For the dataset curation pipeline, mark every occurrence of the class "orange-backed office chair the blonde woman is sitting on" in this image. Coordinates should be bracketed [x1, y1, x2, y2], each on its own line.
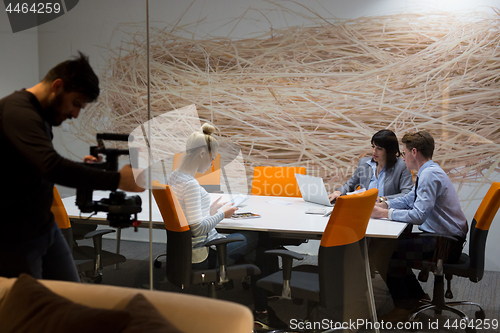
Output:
[153, 181, 260, 298]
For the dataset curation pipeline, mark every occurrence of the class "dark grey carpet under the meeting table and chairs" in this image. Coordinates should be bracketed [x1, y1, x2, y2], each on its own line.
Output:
[82, 240, 500, 332]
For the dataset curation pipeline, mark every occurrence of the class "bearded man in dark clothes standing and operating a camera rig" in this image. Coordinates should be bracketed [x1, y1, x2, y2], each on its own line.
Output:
[0, 52, 144, 281]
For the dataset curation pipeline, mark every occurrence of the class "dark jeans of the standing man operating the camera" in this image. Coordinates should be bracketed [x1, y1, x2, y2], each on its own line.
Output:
[0, 223, 80, 282]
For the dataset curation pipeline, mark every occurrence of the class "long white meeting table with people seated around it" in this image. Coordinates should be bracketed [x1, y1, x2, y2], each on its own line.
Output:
[63, 191, 407, 333]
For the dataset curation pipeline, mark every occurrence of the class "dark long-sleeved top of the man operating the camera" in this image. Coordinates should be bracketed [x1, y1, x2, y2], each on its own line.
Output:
[0, 90, 120, 242]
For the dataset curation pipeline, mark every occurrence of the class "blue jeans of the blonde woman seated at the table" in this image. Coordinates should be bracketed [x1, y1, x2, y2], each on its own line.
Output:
[193, 231, 277, 311]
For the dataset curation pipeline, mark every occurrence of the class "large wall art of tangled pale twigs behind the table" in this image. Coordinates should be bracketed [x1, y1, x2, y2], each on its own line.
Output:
[73, 5, 500, 195]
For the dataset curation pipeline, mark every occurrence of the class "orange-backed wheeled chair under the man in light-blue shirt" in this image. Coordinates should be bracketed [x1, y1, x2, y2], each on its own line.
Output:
[409, 182, 500, 324]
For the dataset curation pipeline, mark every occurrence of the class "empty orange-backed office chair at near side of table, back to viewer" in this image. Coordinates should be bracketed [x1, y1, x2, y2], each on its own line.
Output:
[257, 189, 378, 330]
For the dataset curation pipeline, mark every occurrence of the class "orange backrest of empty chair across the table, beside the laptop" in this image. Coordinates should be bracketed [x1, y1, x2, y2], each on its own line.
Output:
[251, 166, 306, 197]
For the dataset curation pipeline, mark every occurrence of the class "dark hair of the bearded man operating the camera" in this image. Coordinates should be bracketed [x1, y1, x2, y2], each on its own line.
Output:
[43, 51, 99, 102]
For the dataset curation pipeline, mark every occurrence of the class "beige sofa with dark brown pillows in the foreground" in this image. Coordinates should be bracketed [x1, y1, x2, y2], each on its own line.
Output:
[0, 275, 253, 333]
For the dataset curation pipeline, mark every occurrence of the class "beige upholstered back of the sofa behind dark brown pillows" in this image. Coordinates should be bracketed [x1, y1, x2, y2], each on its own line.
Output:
[0, 277, 253, 333]
